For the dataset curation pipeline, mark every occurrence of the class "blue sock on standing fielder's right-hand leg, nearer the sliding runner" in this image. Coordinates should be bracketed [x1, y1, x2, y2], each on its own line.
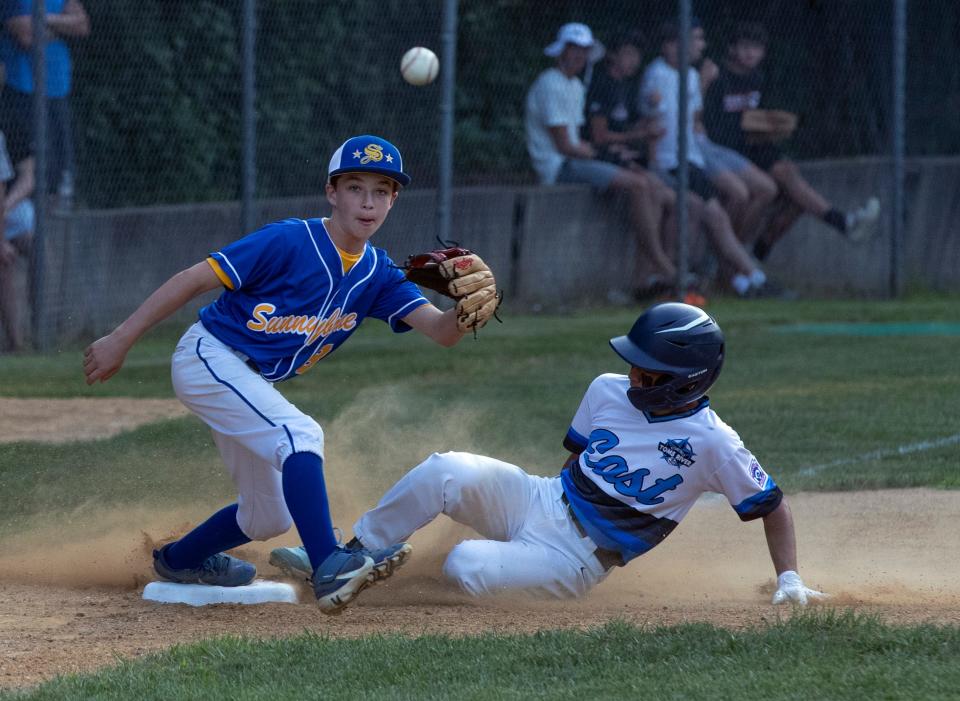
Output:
[283, 453, 337, 569]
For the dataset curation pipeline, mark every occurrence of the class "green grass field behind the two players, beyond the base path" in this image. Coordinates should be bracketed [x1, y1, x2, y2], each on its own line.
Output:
[0, 298, 960, 536]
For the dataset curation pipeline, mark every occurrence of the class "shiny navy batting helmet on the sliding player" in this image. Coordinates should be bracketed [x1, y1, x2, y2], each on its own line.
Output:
[610, 302, 724, 411]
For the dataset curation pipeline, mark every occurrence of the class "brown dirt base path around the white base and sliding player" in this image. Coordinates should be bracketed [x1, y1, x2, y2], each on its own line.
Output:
[0, 489, 960, 687]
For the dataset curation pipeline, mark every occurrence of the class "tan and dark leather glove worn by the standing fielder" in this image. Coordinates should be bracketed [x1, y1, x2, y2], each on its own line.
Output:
[400, 247, 503, 332]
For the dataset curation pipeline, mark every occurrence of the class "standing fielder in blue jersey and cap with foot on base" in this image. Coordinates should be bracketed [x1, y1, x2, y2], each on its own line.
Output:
[83, 136, 495, 613]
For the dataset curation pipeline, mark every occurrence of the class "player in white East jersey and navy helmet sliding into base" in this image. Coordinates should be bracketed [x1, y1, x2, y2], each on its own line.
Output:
[271, 303, 823, 604]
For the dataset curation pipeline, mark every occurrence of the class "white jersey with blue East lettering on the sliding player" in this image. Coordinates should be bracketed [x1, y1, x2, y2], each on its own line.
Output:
[561, 374, 783, 562]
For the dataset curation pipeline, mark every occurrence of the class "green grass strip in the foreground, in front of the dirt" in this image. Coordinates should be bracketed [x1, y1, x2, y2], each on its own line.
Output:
[0, 611, 960, 701]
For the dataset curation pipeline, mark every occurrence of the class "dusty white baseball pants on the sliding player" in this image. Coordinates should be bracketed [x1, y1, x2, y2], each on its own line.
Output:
[353, 453, 607, 598]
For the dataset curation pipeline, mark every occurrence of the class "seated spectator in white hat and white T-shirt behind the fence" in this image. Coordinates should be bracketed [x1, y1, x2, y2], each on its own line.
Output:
[525, 22, 676, 290]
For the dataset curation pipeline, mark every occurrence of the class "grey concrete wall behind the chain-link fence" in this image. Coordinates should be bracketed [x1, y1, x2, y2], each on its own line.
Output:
[9, 158, 960, 342]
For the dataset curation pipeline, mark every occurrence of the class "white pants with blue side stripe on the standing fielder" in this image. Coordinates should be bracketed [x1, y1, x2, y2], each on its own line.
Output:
[171, 321, 323, 540]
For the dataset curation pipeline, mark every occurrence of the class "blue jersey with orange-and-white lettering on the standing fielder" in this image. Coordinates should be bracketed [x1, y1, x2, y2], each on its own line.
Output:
[200, 219, 428, 382]
